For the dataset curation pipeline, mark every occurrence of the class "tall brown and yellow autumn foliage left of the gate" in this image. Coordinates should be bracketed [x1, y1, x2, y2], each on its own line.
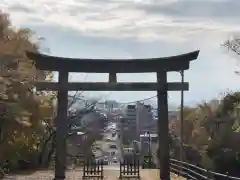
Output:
[0, 13, 52, 173]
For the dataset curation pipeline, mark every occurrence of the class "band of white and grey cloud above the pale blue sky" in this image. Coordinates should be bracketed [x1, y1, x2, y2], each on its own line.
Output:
[0, 0, 240, 42]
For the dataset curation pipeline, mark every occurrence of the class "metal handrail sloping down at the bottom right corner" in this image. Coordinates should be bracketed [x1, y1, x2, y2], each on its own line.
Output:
[170, 159, 240, 180]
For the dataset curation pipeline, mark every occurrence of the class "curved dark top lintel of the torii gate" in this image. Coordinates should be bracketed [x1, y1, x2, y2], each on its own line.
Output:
[26, 51, 199, 73]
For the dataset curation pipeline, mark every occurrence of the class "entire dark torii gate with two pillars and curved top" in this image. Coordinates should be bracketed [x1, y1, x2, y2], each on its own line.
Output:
[26, 51, 199, 180]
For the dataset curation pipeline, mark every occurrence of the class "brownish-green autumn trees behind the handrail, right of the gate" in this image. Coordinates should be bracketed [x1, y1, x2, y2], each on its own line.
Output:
[170, 92, 240, 175]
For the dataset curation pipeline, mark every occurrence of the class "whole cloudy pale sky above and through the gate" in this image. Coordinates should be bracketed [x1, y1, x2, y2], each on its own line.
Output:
[0, 0, 240, 105]
